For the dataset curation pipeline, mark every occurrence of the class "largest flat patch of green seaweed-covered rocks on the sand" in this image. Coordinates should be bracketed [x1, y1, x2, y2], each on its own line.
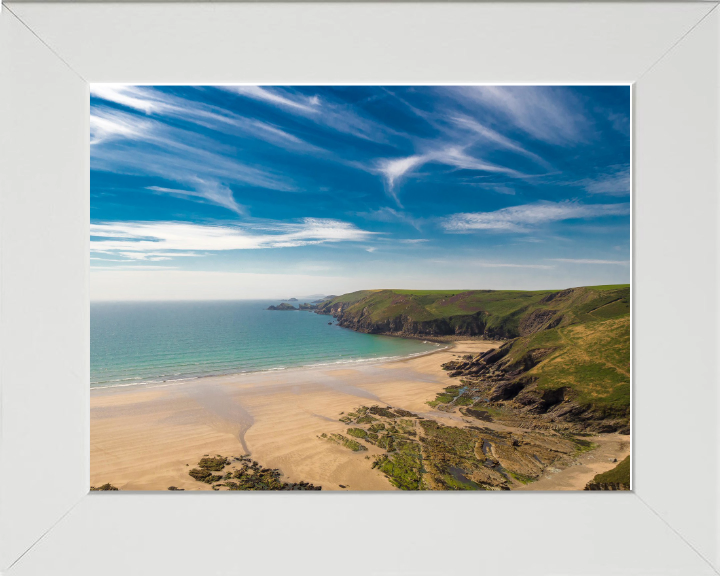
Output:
[318, 405, 595, 490]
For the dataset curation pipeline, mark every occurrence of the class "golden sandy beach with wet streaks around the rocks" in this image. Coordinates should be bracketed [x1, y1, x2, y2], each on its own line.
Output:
[90, 340, 629, 491]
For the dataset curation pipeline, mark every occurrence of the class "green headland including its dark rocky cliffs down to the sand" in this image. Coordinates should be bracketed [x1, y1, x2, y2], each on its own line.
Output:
[316, 286, 630, 434]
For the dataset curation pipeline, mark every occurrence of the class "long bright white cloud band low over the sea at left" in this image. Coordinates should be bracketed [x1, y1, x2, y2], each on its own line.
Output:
[90, 218, 375, 260]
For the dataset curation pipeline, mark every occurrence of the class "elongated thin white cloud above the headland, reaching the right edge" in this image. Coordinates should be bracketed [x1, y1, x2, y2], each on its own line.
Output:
[441, 202, 629, 232]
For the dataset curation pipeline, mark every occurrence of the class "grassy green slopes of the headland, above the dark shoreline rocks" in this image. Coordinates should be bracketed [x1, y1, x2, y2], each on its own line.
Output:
[318, 285, 630, 415]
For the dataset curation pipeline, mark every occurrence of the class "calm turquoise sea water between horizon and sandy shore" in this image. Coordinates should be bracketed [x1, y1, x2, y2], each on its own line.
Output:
[90, 300, 437, 388]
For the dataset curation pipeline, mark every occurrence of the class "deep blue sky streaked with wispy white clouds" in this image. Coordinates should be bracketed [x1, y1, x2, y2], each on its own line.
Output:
[90, 84, 630, 300]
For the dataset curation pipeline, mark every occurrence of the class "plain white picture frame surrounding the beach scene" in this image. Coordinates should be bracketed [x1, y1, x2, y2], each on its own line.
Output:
[0, 1, 720, 576]
